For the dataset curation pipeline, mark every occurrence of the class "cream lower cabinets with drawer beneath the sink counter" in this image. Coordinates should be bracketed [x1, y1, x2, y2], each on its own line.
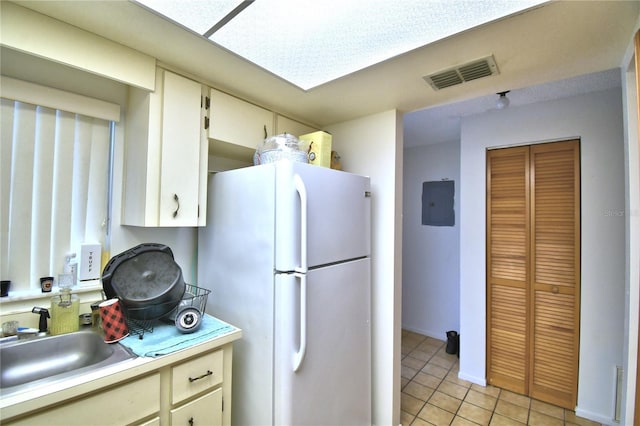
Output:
[2, 343, 232, 426]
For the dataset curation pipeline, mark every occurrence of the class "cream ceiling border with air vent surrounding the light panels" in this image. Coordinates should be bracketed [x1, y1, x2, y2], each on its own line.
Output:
[2, 0, 640, 148]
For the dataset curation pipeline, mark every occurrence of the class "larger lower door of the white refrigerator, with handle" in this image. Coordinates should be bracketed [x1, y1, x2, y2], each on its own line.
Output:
[274, 258, 371, 425]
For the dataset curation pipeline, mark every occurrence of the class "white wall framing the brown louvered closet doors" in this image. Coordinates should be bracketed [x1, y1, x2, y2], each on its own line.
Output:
[460, 89, 625, 424]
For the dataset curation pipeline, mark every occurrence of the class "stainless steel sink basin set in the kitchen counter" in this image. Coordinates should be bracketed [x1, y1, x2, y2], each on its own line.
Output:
[0, 331, 135, 394]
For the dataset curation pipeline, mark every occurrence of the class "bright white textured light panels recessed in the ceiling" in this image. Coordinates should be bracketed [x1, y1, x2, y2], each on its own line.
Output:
[136, 0, 544, 90]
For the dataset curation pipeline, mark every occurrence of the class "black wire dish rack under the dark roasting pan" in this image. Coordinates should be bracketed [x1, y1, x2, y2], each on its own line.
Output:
[125, 284, 211, 339]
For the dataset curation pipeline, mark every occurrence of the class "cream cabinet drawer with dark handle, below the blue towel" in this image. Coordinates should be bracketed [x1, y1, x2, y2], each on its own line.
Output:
[171, 351, 223, 404]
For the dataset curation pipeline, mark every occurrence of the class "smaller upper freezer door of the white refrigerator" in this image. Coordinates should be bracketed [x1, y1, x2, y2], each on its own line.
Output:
[275, 161, 371, 272]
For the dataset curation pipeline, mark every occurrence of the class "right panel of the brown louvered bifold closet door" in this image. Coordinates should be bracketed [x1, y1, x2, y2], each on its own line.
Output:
[530, 141, 580, 409]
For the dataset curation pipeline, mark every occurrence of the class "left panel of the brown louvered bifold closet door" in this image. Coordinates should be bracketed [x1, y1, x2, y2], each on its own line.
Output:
[487, 147, 529, 393]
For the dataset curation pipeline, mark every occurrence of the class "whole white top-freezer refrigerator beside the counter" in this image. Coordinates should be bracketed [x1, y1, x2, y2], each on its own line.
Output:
[198, 160, 371, 426]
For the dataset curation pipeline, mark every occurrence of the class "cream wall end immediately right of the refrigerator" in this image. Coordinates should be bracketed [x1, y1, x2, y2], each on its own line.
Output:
[324, 111, 403, 425]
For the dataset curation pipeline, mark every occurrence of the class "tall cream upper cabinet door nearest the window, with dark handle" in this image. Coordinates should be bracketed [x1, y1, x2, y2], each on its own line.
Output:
[159, 71, 201, 226]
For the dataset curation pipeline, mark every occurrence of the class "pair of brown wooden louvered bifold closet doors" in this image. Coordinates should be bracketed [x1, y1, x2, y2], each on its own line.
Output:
[487, 140, 580, 409]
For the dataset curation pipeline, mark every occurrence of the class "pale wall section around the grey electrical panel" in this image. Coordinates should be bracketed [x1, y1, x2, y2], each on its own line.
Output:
[402, 141, 460, 340]
